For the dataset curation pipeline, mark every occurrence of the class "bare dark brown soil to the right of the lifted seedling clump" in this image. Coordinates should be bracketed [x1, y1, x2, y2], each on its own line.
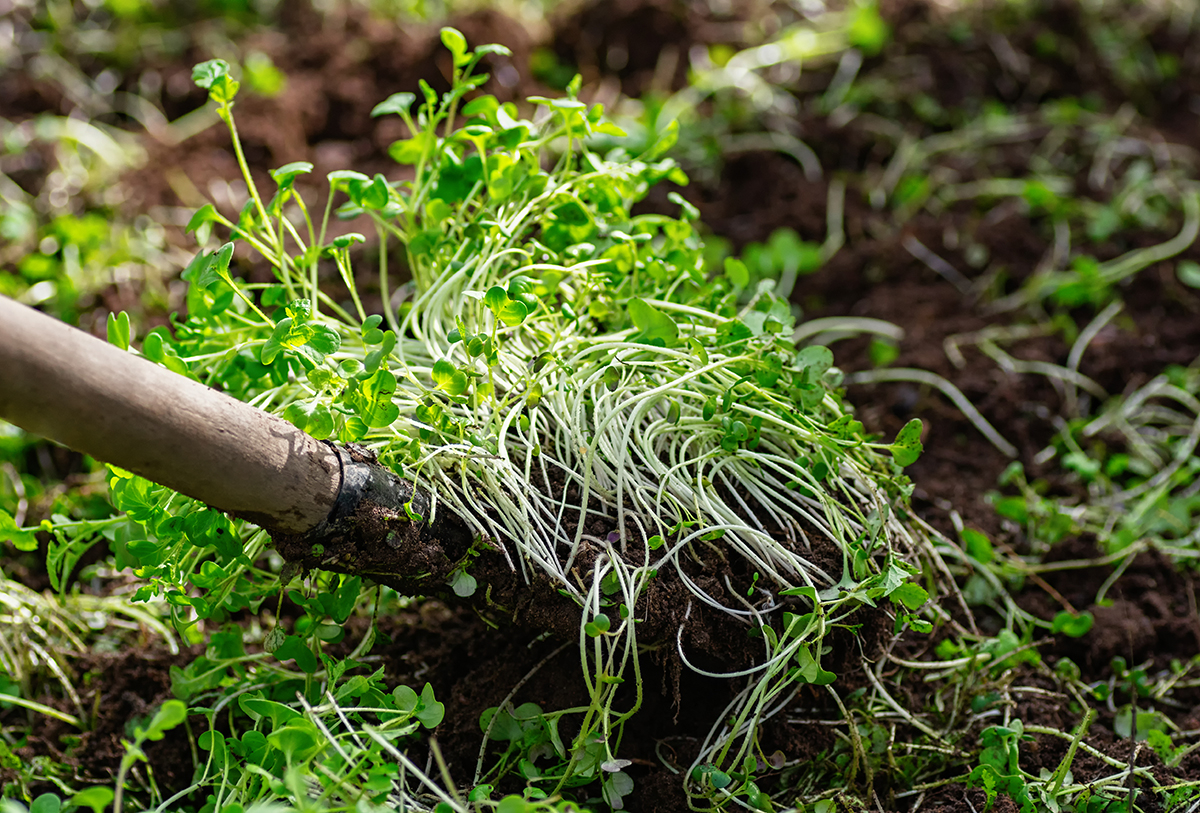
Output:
[660, 2, 1200, 812]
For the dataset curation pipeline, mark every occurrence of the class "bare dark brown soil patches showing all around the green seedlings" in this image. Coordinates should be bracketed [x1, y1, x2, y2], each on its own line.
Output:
[7, 0, 1200, 813]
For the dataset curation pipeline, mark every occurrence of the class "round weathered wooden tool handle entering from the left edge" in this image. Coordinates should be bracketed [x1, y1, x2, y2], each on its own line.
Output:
[0, 296, 342, 534]
